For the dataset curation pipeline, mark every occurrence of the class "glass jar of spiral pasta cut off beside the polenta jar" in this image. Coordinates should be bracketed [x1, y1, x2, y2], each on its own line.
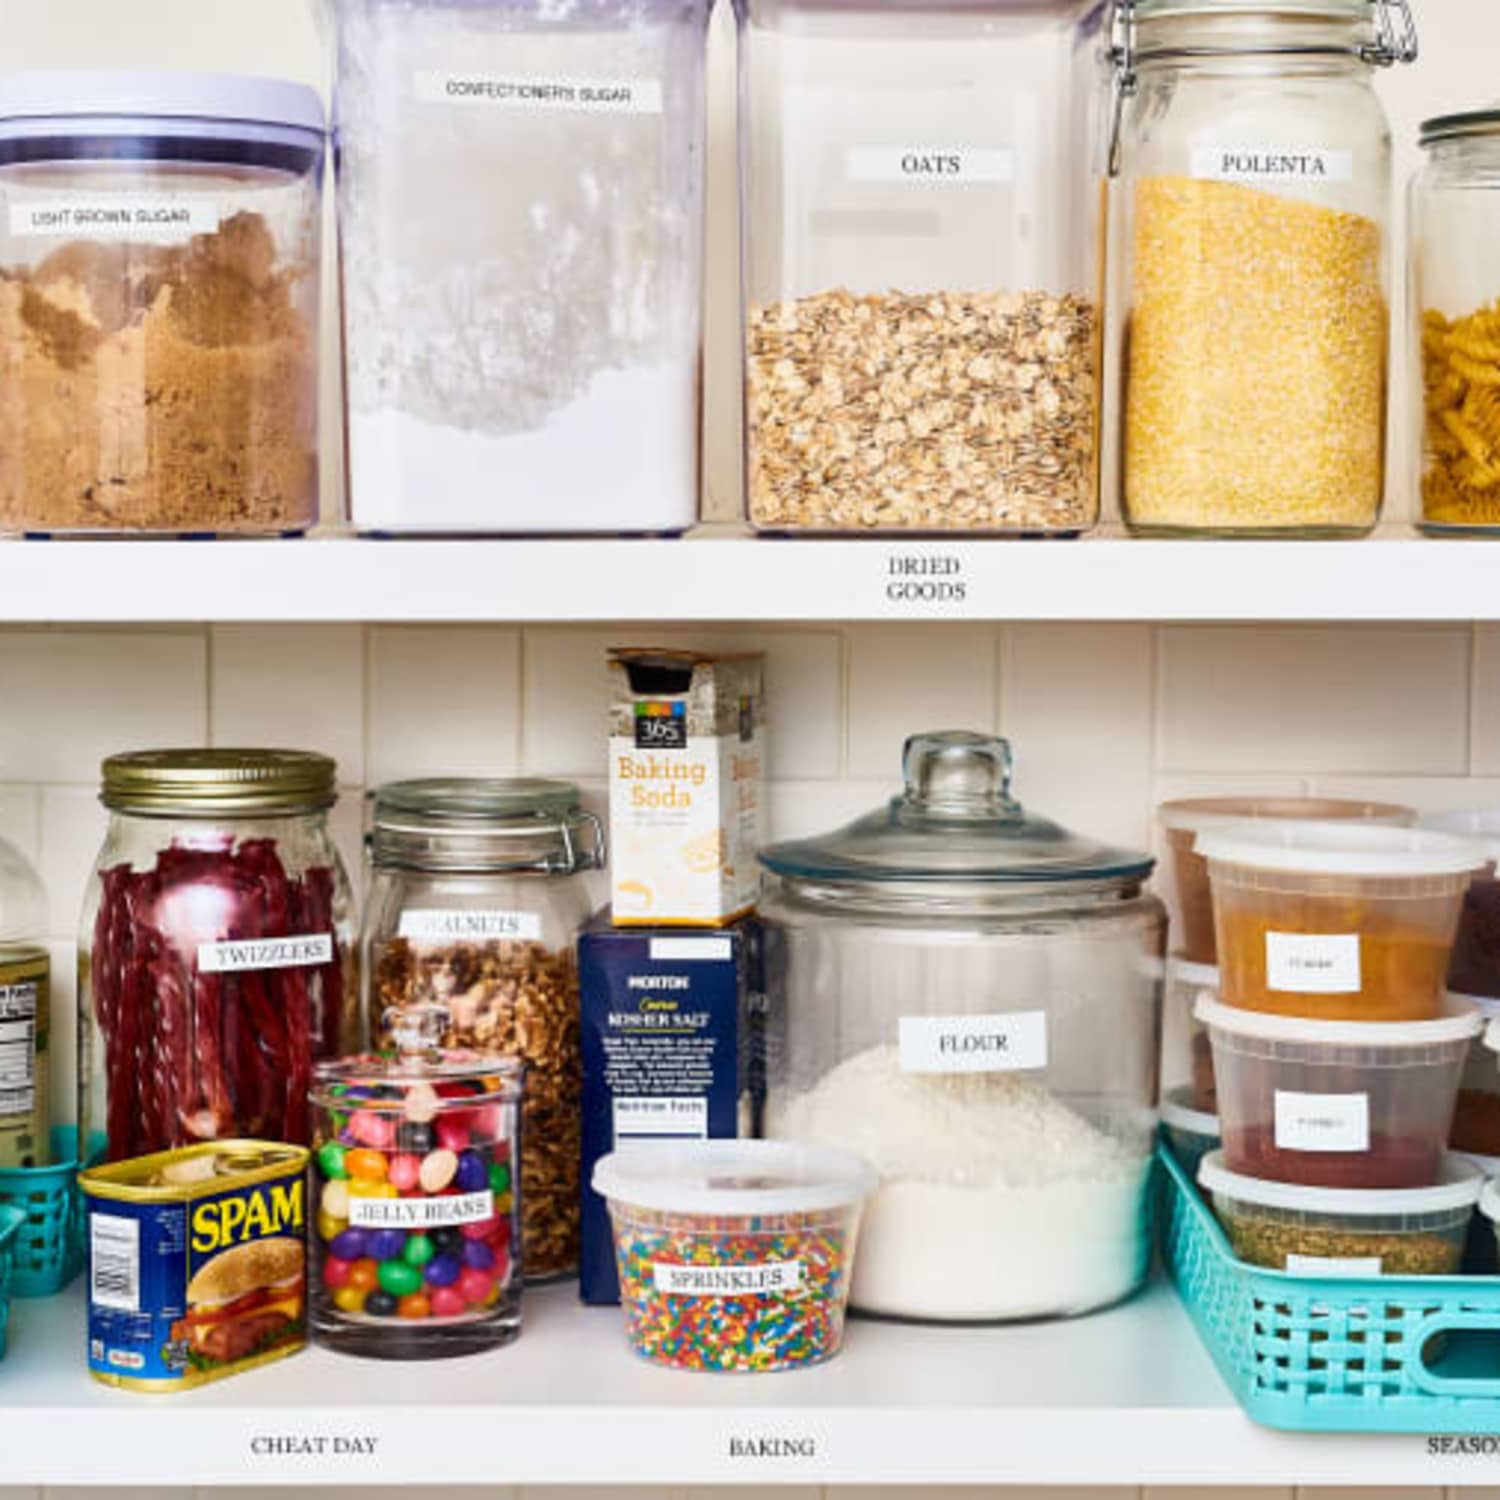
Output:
[1407, 110, 1500, 536]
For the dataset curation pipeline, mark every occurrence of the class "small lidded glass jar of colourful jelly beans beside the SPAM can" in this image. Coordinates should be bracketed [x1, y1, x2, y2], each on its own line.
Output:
[312, 1007, 522, 1359]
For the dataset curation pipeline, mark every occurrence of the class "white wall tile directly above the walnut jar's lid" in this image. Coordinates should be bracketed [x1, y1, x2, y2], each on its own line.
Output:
[366, 626, 521, 786]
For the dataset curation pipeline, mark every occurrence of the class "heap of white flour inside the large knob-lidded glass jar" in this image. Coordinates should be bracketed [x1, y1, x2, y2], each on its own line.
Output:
[767, 1047, 1151, 1320]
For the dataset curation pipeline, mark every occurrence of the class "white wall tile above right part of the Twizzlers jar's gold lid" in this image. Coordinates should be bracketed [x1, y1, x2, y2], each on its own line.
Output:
[209, 626, 365, 785]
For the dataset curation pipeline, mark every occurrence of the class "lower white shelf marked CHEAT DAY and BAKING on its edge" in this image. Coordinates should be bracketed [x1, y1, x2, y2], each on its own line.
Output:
[0, 1284, 1476, 1485]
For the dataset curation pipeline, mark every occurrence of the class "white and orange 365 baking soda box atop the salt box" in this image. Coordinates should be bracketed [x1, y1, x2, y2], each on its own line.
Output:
[609, 650, 765, 927]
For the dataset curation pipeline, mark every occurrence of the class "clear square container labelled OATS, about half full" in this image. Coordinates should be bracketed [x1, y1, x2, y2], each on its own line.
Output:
[737, 0, 1109, 536]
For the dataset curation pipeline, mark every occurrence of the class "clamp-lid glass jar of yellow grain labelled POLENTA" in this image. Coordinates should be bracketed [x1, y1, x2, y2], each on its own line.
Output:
[1119, 0, 1416, 536]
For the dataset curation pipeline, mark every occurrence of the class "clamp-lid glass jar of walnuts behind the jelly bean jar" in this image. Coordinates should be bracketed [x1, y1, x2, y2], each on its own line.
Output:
[363, 779, 605, 1278]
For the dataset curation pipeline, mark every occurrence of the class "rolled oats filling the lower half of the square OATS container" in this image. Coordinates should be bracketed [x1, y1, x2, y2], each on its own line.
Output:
[746, 290, 1100, 533]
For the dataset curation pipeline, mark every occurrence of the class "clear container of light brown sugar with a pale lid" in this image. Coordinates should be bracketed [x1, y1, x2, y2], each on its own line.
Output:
[0, 72, 326, 536]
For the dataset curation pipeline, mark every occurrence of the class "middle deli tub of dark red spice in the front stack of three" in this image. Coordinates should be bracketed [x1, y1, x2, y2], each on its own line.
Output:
[1197, 1001, 1484, 1188]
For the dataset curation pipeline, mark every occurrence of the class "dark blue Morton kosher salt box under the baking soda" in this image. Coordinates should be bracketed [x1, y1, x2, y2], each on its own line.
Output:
[578, 911, 765, 1305]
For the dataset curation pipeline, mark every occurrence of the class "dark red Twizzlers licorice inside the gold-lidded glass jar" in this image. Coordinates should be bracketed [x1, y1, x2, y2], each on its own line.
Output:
[92, 834, 348, 1160]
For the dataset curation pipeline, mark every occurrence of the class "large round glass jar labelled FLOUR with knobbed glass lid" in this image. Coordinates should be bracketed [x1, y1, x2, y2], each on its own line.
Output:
[761, 732, 1166, 1322]
